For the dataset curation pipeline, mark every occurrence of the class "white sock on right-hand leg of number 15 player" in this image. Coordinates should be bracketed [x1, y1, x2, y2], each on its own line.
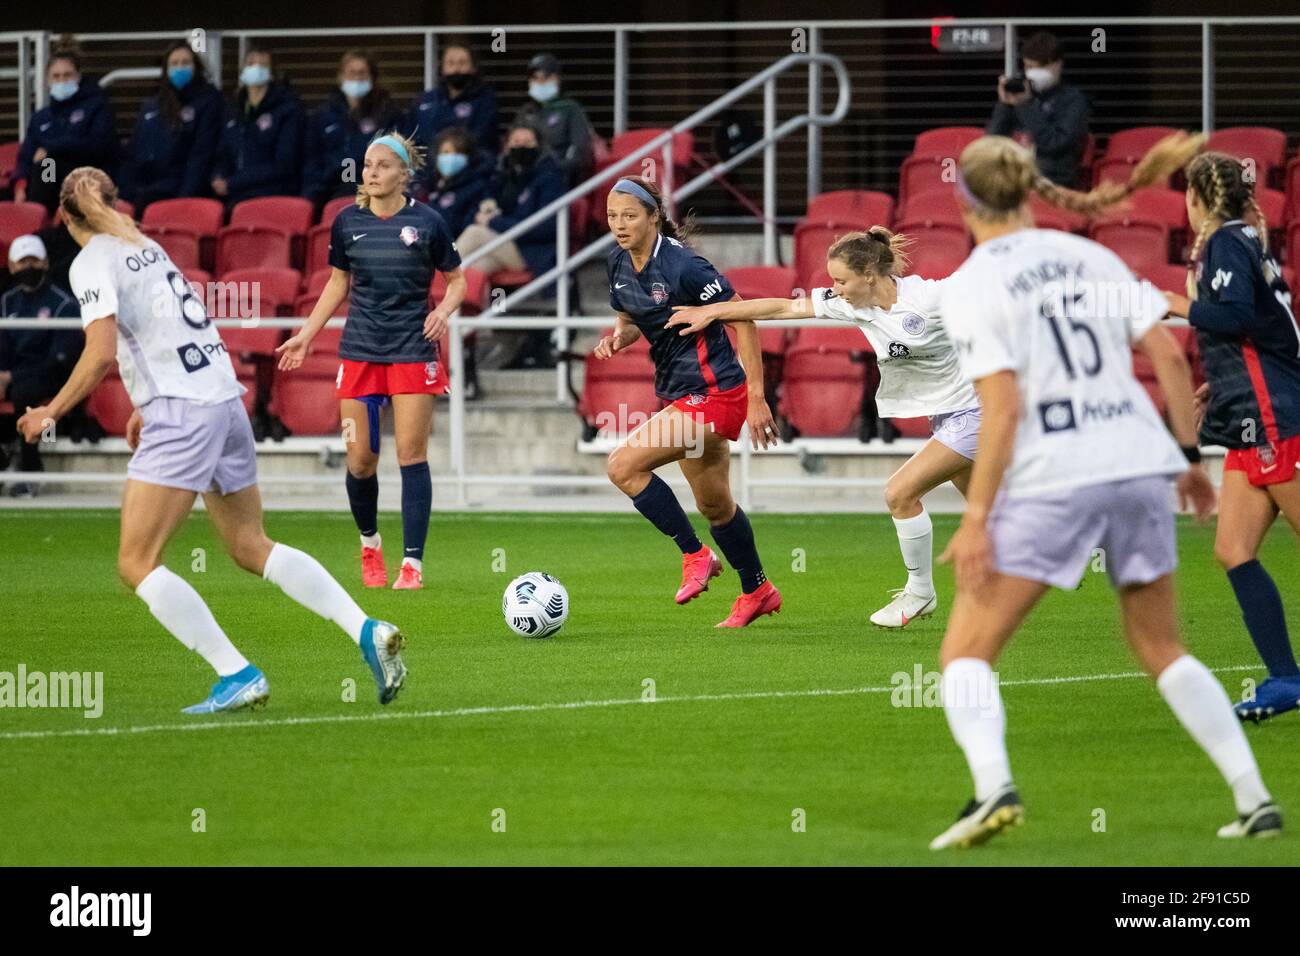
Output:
[1156, 654, 1270, 813]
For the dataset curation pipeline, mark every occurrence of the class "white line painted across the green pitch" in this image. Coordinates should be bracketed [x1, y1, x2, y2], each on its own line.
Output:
[0, 663, 1261, 740]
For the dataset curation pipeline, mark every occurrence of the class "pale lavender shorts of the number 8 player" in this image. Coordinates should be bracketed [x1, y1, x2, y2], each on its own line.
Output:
[126, 398, 257, 494]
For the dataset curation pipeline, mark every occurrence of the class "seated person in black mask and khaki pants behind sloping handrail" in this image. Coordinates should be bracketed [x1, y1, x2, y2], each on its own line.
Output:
[456, 122, 568, 368]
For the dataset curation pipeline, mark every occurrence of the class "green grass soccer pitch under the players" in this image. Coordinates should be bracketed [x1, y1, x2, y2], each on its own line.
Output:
[0, 510, 1300, 865]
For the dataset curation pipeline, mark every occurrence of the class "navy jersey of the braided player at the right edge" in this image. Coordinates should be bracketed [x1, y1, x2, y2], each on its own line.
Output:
[1188, 220, 1300, 449]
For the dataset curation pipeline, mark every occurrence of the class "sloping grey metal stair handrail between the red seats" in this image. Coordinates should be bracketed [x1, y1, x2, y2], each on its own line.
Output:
[463, 53, 849, 401]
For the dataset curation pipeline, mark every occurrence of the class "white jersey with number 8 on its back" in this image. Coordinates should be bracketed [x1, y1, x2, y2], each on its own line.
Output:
[69, 234, 244, 408]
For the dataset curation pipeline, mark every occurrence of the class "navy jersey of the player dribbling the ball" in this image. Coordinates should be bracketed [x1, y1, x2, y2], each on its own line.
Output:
[608, 235, 745, 402]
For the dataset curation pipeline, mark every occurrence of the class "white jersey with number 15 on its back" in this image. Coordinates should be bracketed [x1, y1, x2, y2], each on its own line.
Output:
[943, 229, 1187, 497]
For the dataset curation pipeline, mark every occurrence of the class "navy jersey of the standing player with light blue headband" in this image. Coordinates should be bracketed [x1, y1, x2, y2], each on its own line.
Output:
[329, 199, 460, 363]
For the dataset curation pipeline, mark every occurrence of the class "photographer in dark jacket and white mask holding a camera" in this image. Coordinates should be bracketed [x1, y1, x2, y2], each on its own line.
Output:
[985, 31, 1088, 187]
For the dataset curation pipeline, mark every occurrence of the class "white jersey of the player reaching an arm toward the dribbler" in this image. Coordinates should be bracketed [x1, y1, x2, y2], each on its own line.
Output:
[813, 276, 979, 419]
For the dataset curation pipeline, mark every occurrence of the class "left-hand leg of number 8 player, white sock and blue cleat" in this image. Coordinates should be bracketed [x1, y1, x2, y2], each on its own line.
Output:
[117, 479, 269, 713]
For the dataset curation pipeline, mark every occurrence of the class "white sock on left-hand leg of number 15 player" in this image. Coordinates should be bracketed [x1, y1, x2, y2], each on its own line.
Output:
[941, 657, 1011, 800]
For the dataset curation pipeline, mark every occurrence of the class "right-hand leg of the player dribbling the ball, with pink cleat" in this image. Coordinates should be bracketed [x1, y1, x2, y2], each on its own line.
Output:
[679, 415, 781, 627]
